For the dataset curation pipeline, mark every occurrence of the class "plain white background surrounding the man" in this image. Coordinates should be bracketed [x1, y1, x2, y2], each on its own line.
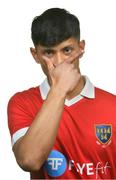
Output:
[0, 0, 116, 180]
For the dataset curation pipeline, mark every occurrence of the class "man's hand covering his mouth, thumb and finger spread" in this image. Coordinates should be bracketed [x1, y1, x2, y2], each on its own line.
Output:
[43, 51, 84, 94]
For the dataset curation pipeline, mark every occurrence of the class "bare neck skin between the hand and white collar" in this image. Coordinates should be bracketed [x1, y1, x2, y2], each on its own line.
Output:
[66, 76, 85, 100]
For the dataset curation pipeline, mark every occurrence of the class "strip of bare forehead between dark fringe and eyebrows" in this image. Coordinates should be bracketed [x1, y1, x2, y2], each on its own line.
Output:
[37, 38, 78, 50]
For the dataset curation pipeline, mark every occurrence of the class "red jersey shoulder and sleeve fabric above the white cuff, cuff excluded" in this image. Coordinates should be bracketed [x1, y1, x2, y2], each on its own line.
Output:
[7, 87, 42, 135]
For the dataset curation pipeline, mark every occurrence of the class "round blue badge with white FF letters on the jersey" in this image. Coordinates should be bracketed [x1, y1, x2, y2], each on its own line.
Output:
[44, 150, 67, 177]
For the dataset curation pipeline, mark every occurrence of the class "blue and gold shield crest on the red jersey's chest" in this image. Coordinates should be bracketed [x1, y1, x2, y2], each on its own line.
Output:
[95, 124, 112, 145]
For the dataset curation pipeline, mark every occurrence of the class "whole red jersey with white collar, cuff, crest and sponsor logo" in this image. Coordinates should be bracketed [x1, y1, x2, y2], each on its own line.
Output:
[8, 77, 116, 179]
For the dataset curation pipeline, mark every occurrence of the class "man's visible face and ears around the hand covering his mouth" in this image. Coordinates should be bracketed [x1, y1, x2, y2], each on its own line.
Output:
[30, 38, 85, 76]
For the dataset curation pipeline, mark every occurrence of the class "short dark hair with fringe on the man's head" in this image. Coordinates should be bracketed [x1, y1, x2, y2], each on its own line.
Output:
[31, 8, 80, 46]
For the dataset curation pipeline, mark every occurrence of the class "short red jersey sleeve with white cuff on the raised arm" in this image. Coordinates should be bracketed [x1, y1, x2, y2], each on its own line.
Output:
[8, 93, 34, 146]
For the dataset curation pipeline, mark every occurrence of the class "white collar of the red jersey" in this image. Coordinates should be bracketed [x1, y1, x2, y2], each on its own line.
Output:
[39, 76, 95, 106]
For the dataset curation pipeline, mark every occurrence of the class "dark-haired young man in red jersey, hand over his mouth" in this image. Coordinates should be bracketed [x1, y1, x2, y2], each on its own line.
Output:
[8, 8, 116, 179]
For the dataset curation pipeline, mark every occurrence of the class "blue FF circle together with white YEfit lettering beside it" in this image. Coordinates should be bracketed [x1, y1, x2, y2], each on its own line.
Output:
[44, 150, 111, 179]
